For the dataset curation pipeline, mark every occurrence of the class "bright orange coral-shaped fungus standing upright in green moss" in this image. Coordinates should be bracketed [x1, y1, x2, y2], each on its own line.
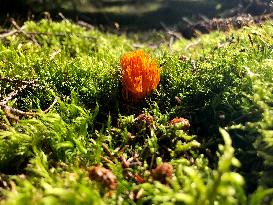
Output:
[120, 50, 160, 102]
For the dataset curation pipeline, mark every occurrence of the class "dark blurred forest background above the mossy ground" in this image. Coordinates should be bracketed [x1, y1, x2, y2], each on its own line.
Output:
[0, 0, 272, 31]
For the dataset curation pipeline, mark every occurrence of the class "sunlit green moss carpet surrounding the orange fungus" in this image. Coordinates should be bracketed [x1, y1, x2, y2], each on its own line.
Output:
[0, 20, 273, 204]
